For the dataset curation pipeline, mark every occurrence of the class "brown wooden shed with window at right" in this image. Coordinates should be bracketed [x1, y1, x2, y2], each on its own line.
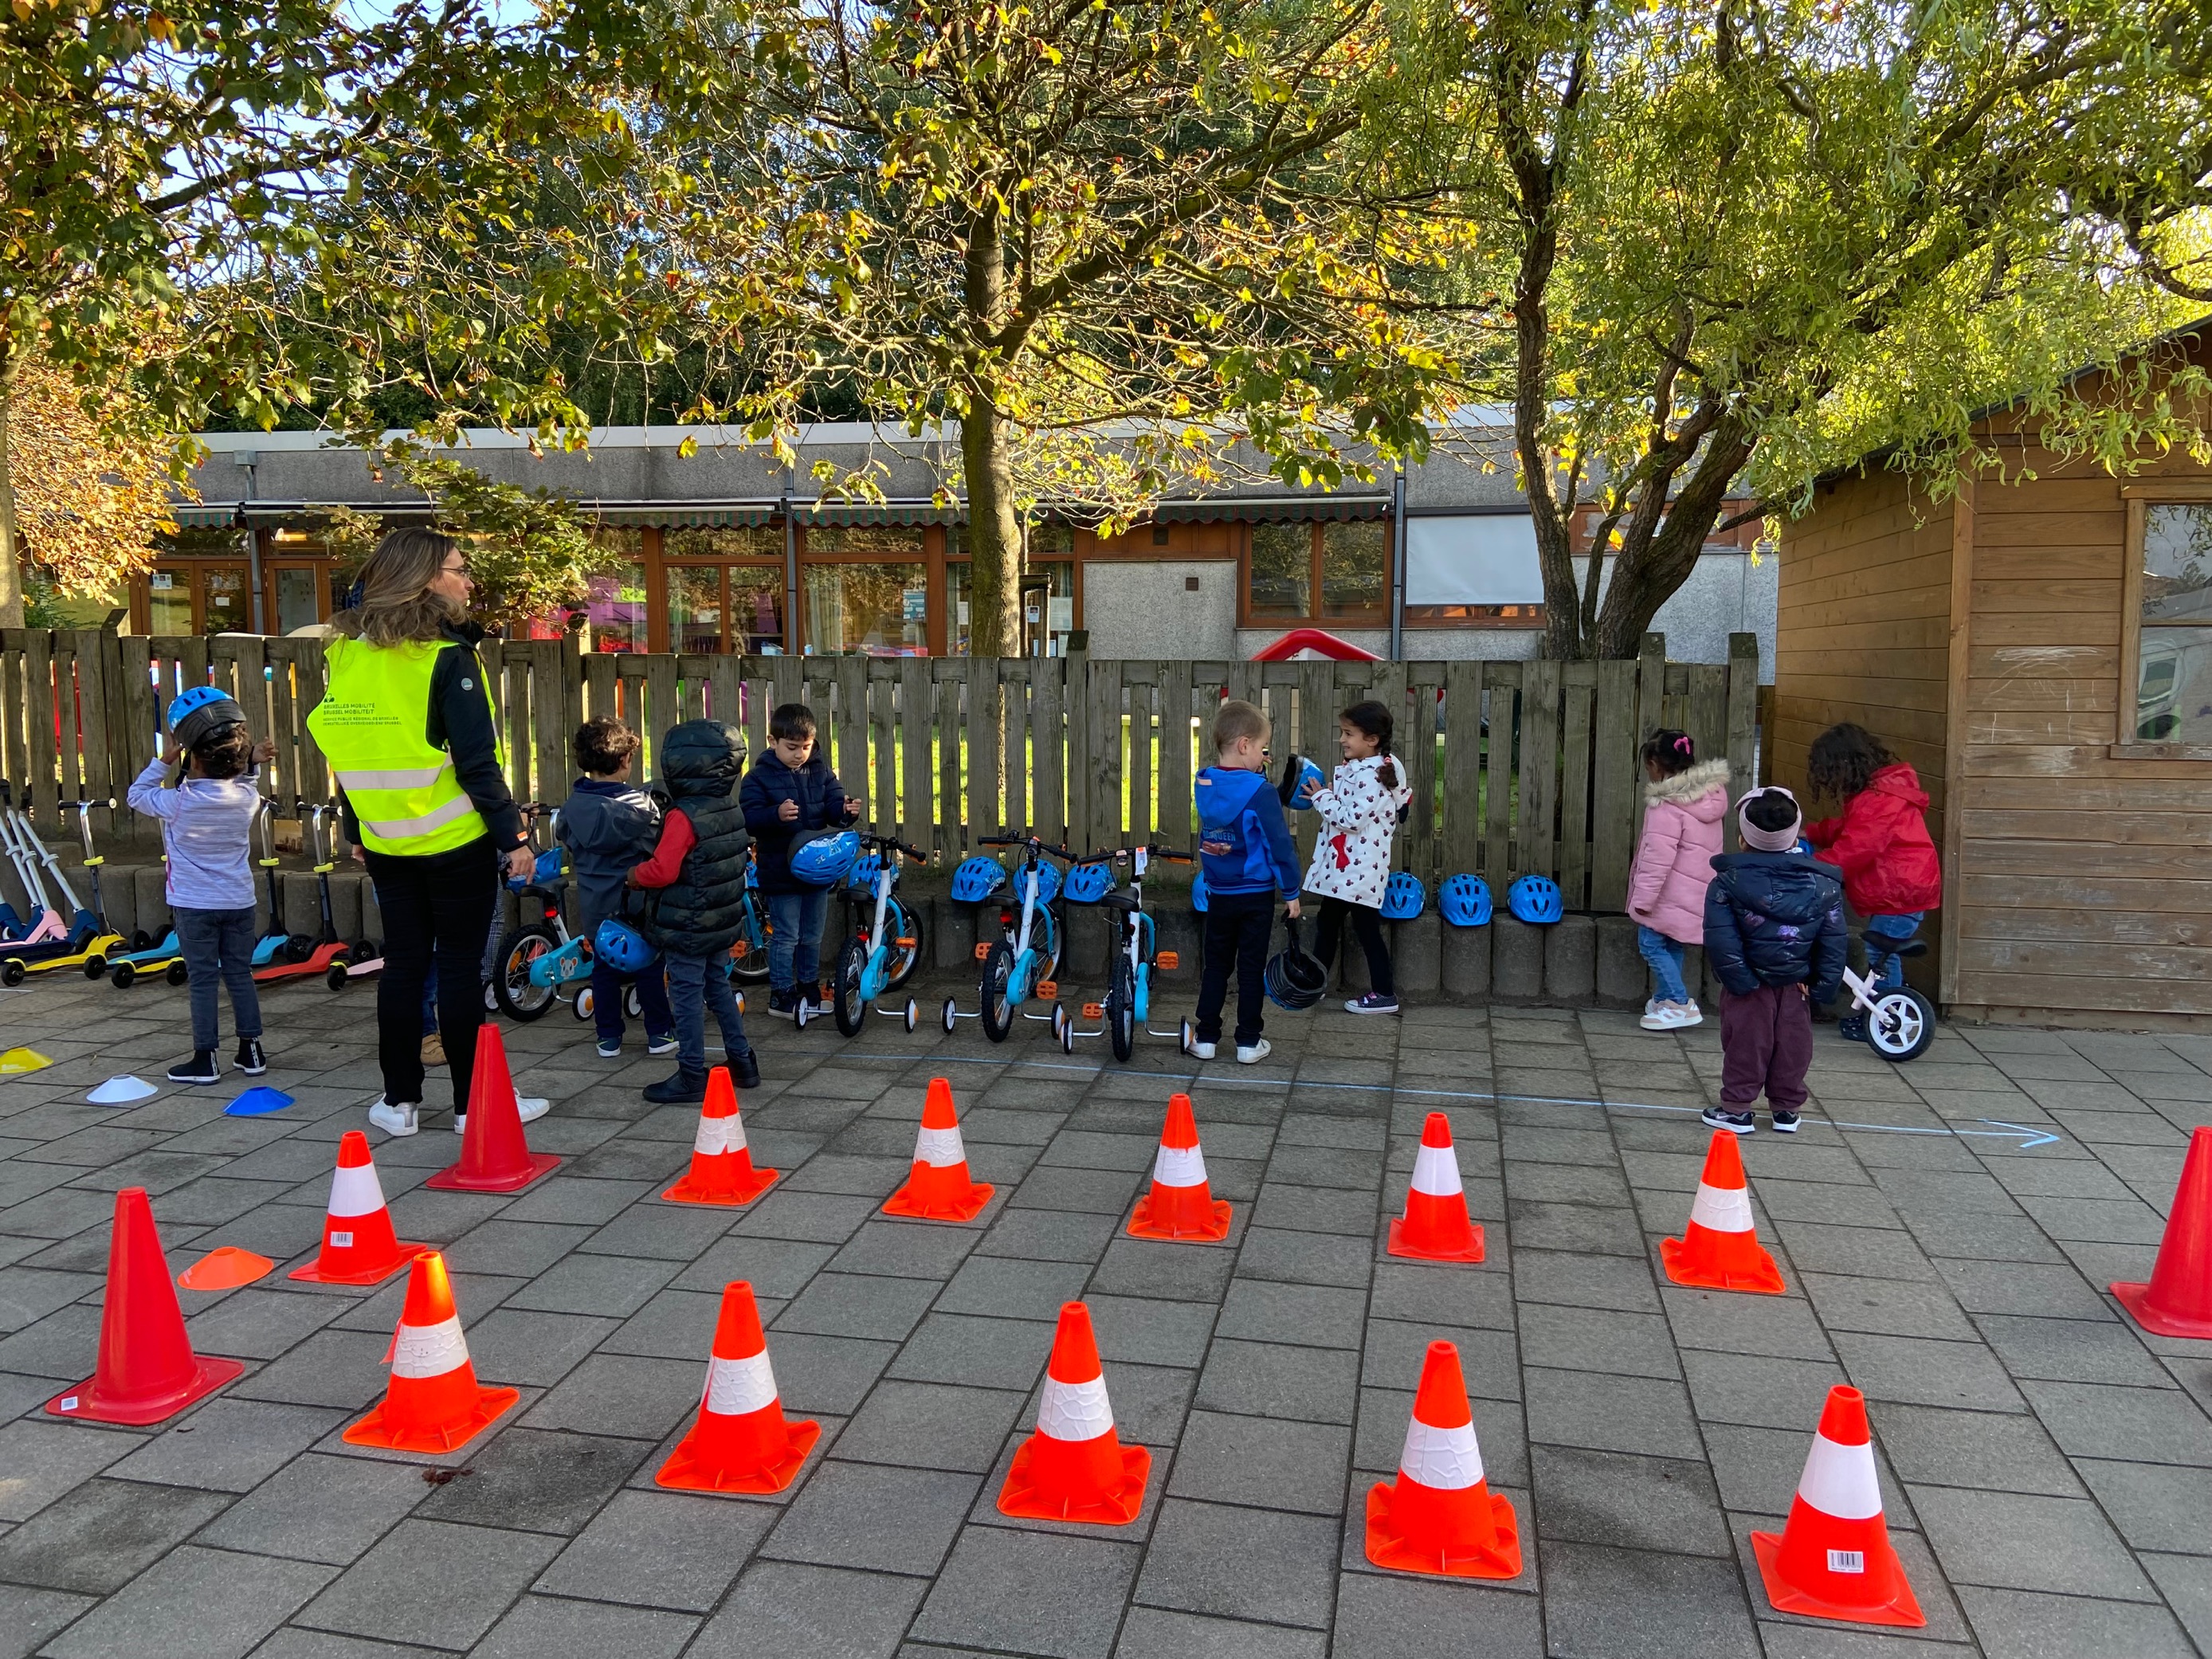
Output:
[1765, 319, 2212, 1029]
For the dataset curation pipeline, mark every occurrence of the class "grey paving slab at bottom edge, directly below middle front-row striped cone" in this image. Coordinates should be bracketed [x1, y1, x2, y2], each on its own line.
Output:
[913, 1526, 1139, 1659]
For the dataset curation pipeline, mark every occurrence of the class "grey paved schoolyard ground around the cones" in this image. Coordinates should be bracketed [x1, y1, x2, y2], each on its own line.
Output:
[0, 980, 2212, 1659]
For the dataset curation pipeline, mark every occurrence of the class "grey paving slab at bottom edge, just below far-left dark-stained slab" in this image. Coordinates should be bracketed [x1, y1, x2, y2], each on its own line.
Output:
[45, 1546, 334, 1659]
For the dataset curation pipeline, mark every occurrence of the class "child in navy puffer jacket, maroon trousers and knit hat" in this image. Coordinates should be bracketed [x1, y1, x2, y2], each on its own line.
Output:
[1705, 787, 1845, 1135]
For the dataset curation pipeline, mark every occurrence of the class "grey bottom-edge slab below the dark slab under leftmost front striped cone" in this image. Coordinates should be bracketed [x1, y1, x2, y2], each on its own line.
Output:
[294, 1530, 559, 1648]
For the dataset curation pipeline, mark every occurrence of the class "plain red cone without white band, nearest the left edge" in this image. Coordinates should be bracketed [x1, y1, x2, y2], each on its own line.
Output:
[46, 1186, 245, 1429]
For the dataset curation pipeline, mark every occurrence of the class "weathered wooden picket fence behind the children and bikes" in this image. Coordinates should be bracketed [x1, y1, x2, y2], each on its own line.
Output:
[0, 628, 1759, 909]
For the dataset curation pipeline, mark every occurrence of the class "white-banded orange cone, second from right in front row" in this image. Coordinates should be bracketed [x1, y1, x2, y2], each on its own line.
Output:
[1367, 1343, 1522, 1579]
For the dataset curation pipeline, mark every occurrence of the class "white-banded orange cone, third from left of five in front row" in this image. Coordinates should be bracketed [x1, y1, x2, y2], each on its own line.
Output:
[998, 1303, 1152, 1526]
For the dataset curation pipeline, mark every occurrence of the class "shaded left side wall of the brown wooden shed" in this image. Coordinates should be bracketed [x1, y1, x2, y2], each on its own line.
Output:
[1765, 473, 1953, 991]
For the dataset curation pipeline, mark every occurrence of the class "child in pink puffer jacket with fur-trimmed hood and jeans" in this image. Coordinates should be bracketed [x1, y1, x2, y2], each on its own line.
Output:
[1628, 730, 1728, 1031]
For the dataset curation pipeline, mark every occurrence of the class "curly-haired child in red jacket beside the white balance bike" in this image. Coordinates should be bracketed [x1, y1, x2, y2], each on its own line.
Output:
[1805, 721, 1942, 1037]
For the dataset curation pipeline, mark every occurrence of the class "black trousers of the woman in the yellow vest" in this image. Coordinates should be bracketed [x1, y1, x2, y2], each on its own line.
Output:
[365, 836, 500, 1115]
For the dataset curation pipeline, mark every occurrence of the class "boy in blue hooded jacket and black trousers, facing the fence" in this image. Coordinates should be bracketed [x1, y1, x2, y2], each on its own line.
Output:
[1190, 701, 1299, 1066]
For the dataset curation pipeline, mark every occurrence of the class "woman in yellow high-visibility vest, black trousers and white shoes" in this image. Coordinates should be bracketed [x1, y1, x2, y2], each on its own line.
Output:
[308, 528, 547, 1135]
